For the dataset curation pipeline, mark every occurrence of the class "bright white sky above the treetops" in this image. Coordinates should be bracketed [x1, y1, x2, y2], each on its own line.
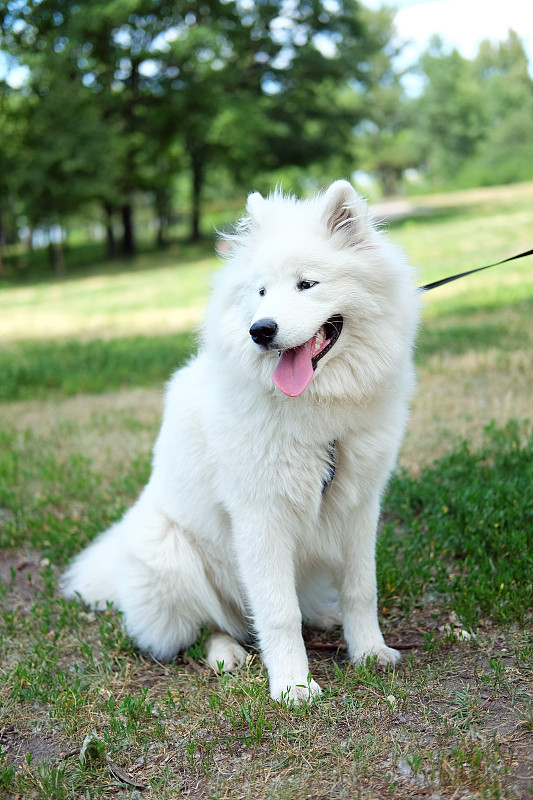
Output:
[0, 0, 533, 85]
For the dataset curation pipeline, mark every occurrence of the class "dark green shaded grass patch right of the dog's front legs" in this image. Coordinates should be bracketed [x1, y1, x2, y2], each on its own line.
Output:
[378, 423, 533, 628]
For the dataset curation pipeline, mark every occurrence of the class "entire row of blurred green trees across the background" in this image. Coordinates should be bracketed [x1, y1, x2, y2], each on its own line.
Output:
[0, 0, 533, 274]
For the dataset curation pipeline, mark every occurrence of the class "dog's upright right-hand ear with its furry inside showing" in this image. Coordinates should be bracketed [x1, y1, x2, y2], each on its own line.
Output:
[322, 181, 367, 244]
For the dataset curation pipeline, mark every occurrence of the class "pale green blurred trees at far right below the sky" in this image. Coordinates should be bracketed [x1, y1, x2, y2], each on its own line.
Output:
[416, 31, 533, 186]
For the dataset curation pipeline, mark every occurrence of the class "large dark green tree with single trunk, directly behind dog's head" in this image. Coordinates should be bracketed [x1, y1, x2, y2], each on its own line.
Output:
[155, 0, 381, 238]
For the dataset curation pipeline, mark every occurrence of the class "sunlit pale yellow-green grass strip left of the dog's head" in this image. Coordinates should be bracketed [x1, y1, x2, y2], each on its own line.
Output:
[0, 255, 219, 343]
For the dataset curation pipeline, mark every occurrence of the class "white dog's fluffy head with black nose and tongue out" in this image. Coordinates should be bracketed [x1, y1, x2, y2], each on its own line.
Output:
[206, 181, 418, 397]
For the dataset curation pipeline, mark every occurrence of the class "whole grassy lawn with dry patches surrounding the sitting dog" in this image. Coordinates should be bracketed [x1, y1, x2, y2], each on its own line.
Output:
[0, 184, 533, 800]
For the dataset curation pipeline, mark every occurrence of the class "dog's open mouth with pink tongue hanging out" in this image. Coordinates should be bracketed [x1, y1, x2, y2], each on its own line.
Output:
[272, 314, 343, 397]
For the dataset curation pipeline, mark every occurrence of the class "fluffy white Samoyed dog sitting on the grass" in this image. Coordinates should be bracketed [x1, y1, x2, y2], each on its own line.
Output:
[63, 180, 419, 703]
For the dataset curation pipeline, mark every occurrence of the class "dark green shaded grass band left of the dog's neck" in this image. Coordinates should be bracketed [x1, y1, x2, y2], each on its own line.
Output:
[0, 332, 196, 402]
